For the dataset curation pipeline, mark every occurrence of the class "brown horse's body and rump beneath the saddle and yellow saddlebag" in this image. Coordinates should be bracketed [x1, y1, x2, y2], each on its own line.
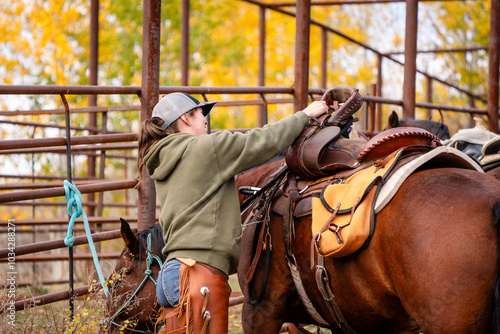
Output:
[237, 155, 500, 334]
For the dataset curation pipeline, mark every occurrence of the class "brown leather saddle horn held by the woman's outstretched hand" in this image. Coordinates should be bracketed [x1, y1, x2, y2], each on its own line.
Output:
[321, 86, 363, 126]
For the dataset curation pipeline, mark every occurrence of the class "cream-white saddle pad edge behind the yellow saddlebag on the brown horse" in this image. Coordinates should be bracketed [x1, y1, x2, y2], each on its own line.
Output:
[374, 146, 484, 213]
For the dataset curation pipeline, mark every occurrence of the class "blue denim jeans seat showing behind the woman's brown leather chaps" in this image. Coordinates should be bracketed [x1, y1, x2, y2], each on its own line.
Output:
[156, 259, 181, 307]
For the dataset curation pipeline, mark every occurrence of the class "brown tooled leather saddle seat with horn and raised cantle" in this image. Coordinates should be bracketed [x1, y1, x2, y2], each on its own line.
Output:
[285, 86, 438, 180]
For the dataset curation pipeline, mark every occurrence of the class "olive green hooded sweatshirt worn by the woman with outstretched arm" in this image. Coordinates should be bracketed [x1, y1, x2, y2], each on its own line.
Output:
[144, 112, 308, 275]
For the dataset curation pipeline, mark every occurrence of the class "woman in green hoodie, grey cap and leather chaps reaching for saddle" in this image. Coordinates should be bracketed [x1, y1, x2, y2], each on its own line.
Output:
[137, 93, 328, 333]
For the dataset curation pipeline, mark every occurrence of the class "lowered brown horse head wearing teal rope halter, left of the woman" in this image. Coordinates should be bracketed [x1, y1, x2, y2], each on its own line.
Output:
[106, 219, 165, 333]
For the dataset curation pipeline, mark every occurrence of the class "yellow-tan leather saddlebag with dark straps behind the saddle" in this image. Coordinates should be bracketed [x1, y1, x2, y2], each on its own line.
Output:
[311, 149, 404, 258]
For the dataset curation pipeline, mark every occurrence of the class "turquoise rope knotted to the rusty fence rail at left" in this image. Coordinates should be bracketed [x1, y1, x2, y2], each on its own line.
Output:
[63, 180, 108, 297]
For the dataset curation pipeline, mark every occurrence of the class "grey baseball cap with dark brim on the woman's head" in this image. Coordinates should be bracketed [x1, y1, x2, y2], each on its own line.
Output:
[151, 93, 217, 130]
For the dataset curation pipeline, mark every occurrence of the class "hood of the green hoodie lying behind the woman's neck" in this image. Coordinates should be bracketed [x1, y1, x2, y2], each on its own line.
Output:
[143, 133, 196, 181]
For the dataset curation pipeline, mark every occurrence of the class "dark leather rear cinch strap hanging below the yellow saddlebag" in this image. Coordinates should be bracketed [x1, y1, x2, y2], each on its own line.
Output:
[316, 254, 356, 334]
